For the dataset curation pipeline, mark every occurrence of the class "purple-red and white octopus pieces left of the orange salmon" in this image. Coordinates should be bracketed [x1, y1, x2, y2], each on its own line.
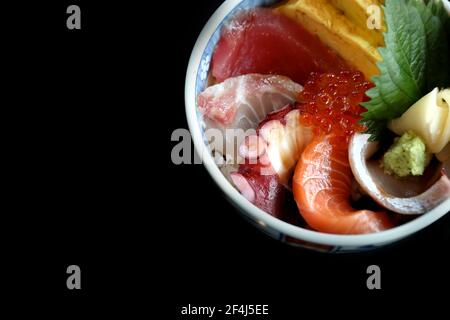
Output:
[231, 105, 312, 217]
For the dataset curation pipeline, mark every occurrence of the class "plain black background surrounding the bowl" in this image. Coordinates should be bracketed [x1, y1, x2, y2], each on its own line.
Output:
[4, 0, 450, 319]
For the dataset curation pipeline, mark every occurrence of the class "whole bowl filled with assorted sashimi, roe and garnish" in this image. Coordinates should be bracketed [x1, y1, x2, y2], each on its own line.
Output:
[186, 0, 450, 252]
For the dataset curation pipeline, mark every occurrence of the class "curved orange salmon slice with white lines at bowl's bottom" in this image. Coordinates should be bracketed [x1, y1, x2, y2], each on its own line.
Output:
[293, 134, 393, 234]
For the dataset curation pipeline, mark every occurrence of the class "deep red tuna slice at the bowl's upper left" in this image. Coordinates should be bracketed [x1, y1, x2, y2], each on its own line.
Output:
[212, 8, 351, 84]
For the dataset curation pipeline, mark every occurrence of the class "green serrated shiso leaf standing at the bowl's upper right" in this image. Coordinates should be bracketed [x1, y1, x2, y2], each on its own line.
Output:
[361, 0, 450, 140]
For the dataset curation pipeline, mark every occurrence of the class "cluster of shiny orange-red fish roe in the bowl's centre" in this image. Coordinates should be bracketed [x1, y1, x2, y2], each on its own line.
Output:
[299, 71, 373, 138]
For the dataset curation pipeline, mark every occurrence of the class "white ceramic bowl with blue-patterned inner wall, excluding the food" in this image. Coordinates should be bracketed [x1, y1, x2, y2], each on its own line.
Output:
[185, 0, 450, 252]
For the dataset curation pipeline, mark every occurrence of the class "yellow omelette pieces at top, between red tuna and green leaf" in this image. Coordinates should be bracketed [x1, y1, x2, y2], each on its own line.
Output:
[276, 0, 386, 79]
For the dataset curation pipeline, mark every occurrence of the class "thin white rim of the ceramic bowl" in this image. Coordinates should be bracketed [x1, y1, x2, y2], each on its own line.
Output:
[185, 0, 450, 247]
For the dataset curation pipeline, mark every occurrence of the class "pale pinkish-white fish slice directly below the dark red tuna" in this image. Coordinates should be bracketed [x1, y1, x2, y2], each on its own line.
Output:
[198, 74, 303, 130]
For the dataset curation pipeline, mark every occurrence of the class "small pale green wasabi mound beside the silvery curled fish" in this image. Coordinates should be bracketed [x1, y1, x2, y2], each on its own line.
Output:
[382, 131, 432, 177]
